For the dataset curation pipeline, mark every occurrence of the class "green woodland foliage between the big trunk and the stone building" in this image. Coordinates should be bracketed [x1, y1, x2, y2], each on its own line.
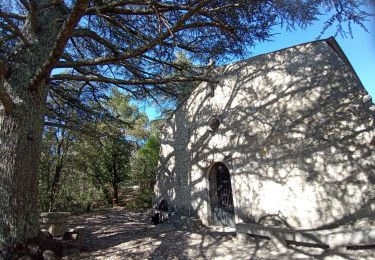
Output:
[39, 91, 162, 213]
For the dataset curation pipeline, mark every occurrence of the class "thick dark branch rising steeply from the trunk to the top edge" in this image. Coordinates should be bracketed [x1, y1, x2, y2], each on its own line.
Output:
[30, 0, 89, 91]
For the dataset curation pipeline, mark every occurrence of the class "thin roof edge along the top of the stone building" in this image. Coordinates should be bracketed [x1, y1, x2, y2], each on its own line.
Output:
[160, 36, 368, 129]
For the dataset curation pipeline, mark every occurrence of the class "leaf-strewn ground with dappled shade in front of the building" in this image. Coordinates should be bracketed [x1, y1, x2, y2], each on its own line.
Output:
[65, 208, 375, 259]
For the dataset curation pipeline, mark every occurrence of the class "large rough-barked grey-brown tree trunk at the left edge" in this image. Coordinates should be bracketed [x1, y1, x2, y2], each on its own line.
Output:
[0, 0, 70, 250]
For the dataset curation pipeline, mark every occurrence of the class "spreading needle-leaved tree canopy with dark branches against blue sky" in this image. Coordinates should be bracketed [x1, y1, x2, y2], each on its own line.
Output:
[0, 0, 368, 115]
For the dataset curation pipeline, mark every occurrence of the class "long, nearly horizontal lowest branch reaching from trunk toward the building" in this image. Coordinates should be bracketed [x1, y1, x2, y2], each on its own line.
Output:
[51, 74, 214, 85]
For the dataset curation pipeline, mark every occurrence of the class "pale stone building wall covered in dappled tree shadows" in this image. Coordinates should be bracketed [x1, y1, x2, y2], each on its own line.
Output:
[155, 41, 375, 229]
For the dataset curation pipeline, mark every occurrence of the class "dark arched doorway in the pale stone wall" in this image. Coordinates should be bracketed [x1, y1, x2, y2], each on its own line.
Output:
[208, 162, 234, 227]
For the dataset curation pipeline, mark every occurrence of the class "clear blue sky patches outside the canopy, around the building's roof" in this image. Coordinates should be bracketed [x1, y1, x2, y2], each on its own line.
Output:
[145, 6, 375, 119]
